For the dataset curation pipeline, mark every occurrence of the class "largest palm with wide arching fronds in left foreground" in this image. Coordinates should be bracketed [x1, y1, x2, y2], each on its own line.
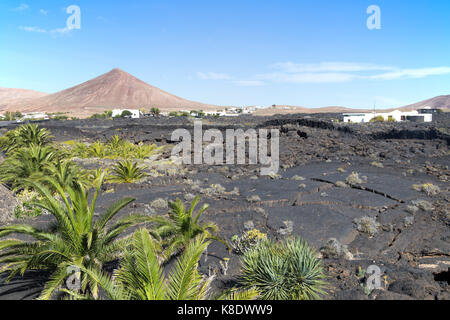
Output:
[0, 174, 148, 299]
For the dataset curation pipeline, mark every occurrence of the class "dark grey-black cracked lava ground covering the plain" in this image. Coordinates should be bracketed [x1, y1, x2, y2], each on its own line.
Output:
[0, 114, 450, 299]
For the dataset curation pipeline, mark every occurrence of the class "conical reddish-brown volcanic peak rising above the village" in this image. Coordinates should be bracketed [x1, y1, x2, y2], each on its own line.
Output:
[0, 69, 217, 116]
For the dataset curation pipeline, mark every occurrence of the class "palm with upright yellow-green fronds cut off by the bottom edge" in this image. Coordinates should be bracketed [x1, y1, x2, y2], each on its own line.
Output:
[66, 229, 258, 300]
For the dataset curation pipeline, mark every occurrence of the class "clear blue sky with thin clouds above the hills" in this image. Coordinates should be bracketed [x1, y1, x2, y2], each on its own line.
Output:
[0, 0, 450, 108]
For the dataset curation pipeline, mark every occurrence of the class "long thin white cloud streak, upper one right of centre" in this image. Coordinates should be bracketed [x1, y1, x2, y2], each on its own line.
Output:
[271, 62, 395, 73]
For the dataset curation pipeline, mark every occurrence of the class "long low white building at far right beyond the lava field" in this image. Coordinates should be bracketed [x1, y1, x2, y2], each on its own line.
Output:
[343, 110, 433, 123]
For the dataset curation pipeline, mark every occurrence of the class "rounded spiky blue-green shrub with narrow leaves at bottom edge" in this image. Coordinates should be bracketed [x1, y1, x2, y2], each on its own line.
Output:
[239, 239, 326, 300]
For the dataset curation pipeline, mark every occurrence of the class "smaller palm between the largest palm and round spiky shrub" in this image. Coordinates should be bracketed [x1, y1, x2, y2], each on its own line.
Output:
[151, 196, 228, 258]
